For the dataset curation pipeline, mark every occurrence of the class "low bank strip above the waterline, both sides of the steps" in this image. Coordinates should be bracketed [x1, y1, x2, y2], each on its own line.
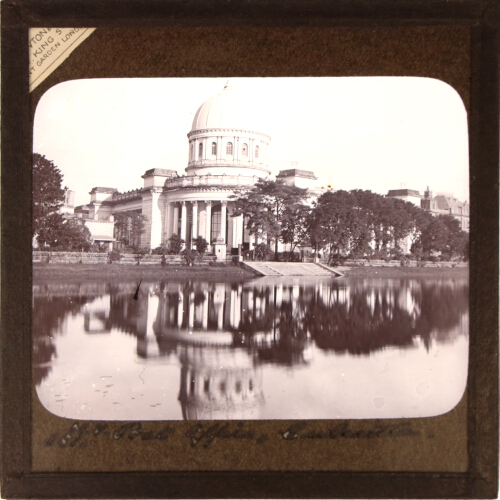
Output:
[33, 263, 469, 282]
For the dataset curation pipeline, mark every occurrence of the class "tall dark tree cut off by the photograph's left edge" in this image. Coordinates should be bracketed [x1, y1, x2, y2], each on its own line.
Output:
[32, 153, 64, 236]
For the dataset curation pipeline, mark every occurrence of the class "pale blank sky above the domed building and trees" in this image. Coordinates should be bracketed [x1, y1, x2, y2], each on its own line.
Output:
[33, 77, 469, 205]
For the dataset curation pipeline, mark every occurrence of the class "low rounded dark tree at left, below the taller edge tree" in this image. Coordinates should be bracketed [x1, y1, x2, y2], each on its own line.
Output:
[37, 213, 92, 252]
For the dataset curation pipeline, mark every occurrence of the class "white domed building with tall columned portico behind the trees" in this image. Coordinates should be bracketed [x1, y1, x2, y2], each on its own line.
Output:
[75, 81, 316, 259]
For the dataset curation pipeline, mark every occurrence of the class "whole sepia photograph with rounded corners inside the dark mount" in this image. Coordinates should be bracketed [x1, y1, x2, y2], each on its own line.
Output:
[32, 77, 470, 421]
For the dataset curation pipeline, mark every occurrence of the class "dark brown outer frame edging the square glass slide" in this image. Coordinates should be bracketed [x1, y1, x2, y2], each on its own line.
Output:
[1, 0, 500, 499]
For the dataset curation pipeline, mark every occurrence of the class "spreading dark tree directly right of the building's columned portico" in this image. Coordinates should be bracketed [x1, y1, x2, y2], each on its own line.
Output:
[233, 179, 307, 259]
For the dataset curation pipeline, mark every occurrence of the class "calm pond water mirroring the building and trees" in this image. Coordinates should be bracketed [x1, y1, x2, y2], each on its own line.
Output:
[33, 277, 469, 420]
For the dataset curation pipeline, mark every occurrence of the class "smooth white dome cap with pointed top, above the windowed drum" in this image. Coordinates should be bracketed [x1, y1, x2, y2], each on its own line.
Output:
[191, 80, 260, 131]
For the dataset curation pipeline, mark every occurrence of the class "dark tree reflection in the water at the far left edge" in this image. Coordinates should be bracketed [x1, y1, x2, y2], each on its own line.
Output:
[33, 296, 89, 385]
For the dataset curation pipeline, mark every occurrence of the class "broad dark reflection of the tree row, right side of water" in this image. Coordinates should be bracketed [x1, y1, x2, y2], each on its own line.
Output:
[306, 280, 468, 354]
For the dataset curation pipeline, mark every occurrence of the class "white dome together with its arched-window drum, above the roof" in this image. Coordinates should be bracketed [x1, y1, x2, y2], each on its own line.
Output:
[186, 82, 271, 177]
